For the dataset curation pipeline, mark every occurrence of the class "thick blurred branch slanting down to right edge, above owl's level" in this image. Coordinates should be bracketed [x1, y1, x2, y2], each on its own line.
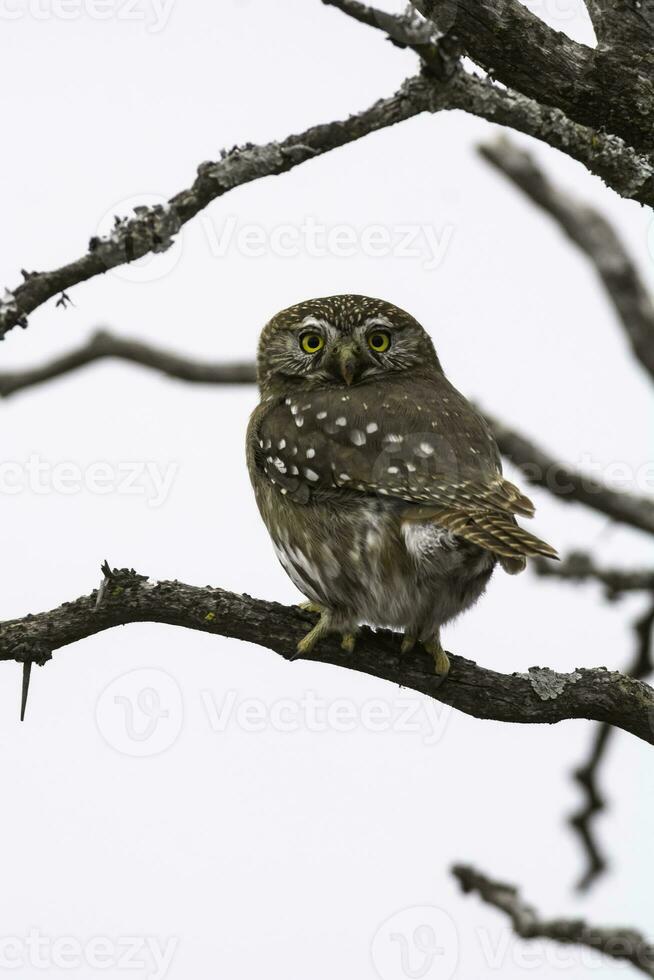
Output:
[479, 138, 654, 378]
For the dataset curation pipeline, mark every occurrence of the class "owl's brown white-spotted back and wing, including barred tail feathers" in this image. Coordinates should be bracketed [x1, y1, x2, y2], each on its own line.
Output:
[251, 378, 556, 570]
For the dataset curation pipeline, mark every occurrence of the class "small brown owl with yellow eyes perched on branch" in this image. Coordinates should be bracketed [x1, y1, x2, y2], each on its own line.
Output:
[247, 295, 556, 679]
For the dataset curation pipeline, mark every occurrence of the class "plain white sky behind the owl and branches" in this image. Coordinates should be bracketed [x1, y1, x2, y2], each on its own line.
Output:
[0, 0, 654, 980]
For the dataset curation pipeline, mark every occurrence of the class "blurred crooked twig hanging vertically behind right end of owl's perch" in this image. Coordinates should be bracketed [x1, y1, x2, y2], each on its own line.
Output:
[570, 605, 654, 891]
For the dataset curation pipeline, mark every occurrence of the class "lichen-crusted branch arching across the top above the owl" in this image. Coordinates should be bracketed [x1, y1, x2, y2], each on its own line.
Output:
[5, 56, 654, 339]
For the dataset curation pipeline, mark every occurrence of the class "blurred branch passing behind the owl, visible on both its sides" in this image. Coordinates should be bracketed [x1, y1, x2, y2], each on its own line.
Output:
[0, 331, 654, 533]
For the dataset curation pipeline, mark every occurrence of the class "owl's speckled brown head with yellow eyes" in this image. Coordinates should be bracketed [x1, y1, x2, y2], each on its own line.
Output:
[257, 295, 441, 391]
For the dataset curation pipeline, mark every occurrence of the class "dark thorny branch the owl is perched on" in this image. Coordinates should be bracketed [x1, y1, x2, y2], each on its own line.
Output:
[0, 565, 654, 744]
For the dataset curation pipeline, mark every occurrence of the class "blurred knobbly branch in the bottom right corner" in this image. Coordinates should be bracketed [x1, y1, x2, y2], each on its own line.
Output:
[452, 865, 654, 977]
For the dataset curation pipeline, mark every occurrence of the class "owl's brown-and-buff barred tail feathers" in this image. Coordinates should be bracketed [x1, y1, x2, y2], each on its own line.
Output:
[420, 509, 559, 575]
